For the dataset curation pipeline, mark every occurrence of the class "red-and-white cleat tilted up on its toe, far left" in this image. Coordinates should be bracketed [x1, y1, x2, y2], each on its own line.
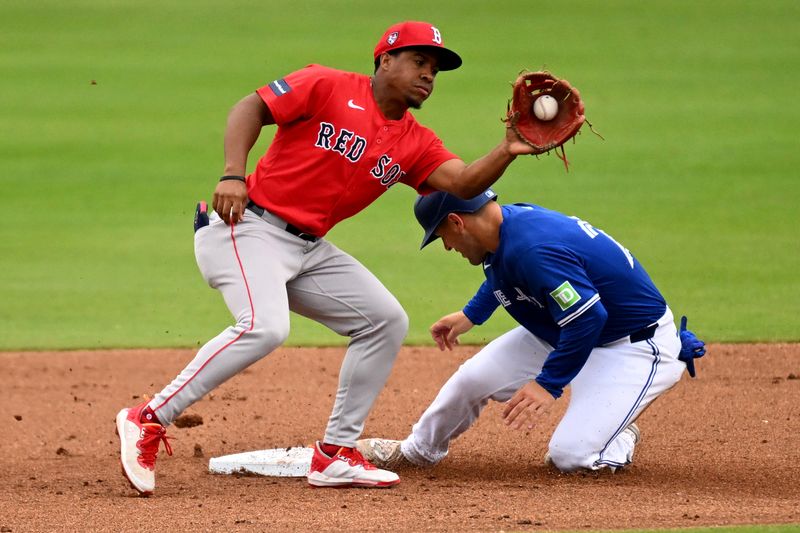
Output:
[117, 403, 172, 496]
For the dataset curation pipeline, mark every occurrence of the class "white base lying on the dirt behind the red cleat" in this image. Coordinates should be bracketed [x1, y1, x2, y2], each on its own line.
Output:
[208, 447, 314, 477]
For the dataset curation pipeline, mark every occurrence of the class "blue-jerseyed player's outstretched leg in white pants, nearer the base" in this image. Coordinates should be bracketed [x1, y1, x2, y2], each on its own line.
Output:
[401, 327, 553, 466]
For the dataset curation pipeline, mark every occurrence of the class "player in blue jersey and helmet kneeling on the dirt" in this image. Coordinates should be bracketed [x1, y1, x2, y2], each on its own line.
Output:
[358, 190, 705, 472]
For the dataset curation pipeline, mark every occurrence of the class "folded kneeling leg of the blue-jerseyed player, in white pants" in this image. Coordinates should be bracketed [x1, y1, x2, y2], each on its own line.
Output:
[549, 310, 685, 472]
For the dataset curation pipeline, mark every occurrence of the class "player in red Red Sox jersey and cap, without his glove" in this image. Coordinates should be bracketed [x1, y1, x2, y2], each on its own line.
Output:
[117, 21, 531, 495]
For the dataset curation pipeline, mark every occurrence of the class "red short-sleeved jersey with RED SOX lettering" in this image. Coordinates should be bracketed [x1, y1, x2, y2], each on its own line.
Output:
[247, 65, 457, 237]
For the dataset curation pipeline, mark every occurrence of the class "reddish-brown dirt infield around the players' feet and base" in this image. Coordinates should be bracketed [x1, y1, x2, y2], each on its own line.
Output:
[0, 344, 800, 532]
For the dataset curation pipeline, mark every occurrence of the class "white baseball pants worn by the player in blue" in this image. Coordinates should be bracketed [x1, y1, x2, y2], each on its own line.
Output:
[401, 309, 686, 472]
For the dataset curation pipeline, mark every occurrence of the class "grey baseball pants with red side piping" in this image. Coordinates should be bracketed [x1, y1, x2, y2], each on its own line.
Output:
[149, 210, 408, 447]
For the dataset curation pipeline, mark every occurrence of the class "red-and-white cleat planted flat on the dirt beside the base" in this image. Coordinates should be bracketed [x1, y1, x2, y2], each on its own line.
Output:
[306, 441, 400, 488]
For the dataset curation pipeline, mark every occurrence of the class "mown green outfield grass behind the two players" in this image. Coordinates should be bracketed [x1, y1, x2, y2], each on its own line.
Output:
[0, 0, 800, 349]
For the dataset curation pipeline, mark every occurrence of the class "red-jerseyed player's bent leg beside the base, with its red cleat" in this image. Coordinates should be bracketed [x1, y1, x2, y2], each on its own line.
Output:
[287, 241, 408, 486]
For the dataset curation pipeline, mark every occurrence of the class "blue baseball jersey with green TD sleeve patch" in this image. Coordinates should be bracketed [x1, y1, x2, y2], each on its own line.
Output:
[464, 204, 667, 397]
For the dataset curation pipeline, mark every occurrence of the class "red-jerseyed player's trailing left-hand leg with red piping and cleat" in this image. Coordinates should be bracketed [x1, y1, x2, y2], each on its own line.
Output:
[117, 212, 299, 494]
